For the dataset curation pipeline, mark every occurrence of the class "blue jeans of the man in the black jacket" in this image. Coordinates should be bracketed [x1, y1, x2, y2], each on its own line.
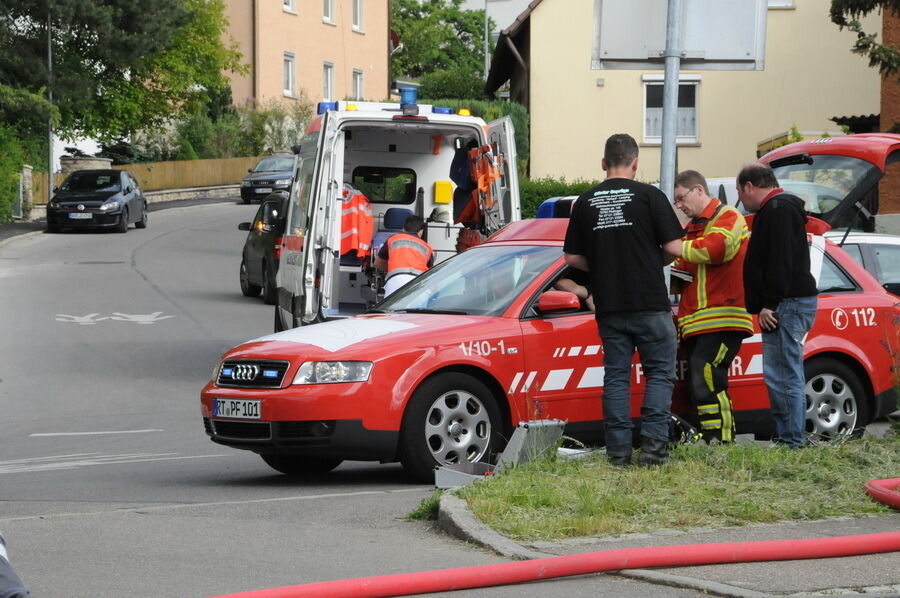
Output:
[762, 295, 818, 448]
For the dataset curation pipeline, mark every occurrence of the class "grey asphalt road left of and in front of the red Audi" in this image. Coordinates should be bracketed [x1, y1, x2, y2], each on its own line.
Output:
[0, 203, 701, 598]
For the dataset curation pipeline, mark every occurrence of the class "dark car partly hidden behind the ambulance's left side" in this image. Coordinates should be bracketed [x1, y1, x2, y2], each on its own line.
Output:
[238, 192, 288, 305]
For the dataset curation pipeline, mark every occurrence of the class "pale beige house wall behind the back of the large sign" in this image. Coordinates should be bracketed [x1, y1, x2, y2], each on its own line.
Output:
[530, 0, 881, 181]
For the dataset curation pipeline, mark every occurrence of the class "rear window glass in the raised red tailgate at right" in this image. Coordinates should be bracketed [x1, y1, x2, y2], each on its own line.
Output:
[772, 155, 875, 228]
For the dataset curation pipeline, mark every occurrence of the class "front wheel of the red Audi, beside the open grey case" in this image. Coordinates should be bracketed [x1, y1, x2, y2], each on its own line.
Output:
[400, 372, 503, 482]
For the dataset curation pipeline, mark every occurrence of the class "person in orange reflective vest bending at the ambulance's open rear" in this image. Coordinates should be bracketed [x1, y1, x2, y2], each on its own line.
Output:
[375, 215, 434, 297]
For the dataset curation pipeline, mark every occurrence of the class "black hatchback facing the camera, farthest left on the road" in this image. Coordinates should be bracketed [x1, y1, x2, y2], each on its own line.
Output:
[47, 170, 148, 233]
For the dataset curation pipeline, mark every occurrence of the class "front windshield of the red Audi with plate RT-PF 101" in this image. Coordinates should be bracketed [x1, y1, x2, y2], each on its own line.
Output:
[376, 245, 562, 316]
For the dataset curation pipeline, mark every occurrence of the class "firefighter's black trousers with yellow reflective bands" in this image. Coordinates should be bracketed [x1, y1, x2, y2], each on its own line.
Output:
[684, 331, 746, 442]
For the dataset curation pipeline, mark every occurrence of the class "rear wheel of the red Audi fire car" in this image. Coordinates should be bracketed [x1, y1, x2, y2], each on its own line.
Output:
[803, 357, 869, 441]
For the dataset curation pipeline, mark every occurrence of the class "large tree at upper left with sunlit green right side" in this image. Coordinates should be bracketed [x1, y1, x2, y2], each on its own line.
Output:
[0, 0, 242, 138]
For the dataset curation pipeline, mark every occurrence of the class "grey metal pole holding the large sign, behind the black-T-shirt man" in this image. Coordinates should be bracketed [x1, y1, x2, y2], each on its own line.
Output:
[659, 0, 682, 200]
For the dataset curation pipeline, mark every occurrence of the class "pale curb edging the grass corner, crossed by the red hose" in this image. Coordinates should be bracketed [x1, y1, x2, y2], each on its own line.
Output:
[438, 493, 771, 598]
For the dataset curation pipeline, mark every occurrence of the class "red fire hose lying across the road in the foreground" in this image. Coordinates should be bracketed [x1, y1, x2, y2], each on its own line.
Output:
[216, 478, 900, 598]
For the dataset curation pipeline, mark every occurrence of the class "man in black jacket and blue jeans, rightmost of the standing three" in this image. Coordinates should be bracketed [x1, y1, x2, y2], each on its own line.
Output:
[737, 163, 818, 448]
